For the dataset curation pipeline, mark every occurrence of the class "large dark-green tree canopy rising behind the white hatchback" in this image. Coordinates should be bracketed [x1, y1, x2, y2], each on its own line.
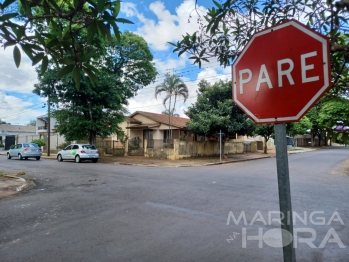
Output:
[33, 32, 157, 143]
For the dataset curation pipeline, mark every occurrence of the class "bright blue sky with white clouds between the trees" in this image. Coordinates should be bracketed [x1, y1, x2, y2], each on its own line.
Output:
[0, 0, 231, 124]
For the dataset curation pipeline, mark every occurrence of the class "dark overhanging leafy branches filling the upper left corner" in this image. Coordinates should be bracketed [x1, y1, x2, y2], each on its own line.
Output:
[0, 0, 132, 88]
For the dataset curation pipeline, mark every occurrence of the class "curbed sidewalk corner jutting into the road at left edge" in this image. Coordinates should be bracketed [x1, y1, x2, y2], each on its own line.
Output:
[0, 171, 35, 199]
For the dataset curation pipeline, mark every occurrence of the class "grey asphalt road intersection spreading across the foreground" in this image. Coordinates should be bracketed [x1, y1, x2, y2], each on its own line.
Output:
[0, 148, 349, 262]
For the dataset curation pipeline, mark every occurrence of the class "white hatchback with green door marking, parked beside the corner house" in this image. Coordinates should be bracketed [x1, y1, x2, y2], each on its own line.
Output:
[57, 144, 99, 163]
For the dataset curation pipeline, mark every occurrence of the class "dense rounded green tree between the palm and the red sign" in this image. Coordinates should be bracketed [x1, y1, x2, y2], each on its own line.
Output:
[186, 80, 254, 136]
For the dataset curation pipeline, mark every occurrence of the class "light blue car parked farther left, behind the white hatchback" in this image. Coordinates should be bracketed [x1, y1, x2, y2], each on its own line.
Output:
[7, 143, 42, 160]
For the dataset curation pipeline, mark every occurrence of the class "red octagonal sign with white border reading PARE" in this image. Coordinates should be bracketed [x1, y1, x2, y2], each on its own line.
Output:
[232, 20, 331, 124]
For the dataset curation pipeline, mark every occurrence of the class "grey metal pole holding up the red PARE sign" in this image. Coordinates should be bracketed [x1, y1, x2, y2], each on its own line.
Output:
[274, 124, 296, 262]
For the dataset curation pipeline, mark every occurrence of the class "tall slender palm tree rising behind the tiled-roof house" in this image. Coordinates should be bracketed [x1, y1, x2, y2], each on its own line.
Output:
[155, 74, 189, 138]
